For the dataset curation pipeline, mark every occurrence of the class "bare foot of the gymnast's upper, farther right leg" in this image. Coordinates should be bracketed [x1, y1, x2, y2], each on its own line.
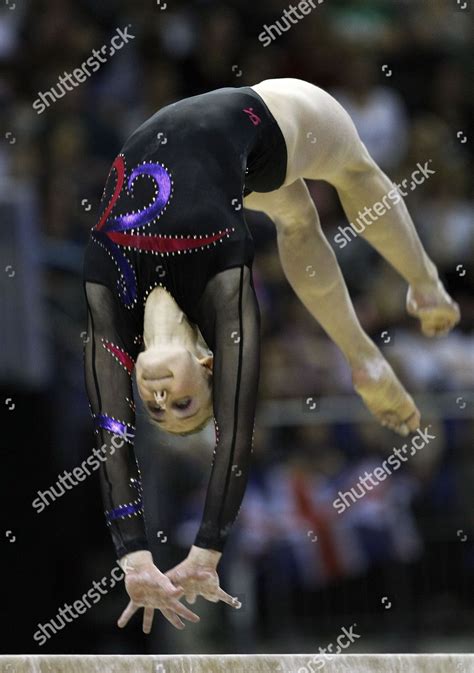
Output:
[406, 281, 461, 337]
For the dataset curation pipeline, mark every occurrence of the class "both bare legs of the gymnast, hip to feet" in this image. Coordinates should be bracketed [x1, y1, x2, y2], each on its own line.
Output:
[244, 79, 460, 435]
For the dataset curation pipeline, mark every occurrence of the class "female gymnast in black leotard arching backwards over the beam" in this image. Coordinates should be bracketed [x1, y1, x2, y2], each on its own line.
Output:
[84, 79, 459, 632]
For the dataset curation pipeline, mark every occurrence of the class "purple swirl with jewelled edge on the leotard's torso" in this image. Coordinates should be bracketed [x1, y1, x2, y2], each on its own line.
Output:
[104, 163, 171, 231]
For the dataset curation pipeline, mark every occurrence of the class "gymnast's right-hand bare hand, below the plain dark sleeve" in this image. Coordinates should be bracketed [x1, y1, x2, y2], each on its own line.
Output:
[166, 546, 241, 609]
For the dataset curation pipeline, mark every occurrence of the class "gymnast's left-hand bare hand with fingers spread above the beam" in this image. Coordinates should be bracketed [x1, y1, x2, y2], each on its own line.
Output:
[117, 551, 200, 633]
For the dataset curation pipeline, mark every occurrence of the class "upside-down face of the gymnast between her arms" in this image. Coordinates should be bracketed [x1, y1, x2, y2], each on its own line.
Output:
[136, 346, 212, 434]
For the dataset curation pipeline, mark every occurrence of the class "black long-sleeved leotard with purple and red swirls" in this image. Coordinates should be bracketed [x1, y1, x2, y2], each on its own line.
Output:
[84, 87, 287, 558]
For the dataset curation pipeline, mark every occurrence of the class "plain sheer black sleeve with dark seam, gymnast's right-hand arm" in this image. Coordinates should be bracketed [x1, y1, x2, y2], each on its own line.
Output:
[195, 266, 260, 551]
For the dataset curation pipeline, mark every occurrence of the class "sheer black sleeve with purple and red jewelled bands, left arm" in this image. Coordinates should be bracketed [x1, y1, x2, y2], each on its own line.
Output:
[84, 282, 148, 558]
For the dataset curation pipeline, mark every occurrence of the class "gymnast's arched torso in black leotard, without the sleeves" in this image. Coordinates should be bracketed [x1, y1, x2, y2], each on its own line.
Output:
[84, 87, 287, 324]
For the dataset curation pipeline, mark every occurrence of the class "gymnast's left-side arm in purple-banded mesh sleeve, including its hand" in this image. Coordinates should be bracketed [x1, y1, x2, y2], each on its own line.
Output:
[84, 282, 198, 632]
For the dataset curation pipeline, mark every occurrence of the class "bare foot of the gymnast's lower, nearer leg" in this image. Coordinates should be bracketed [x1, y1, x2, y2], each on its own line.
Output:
[352, 352, 420, 437]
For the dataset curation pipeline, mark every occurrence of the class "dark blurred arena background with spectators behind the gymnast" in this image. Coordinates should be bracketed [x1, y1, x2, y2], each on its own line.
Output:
[0, 0, 474, 673]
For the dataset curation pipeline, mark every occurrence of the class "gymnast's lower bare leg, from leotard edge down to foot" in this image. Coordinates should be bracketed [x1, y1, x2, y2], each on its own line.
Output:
[245, 180, 420, 435]
